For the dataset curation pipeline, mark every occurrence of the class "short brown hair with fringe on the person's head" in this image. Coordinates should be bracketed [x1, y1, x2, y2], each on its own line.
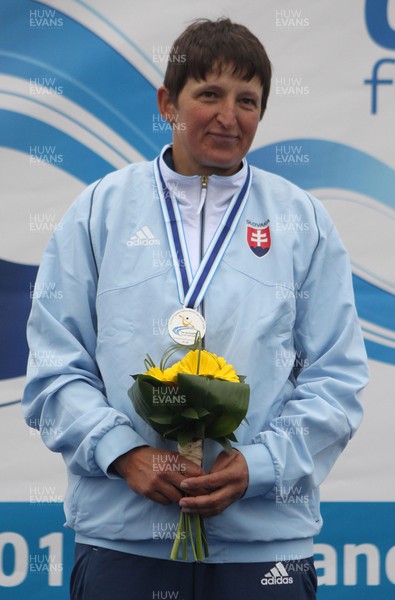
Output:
[163, 18, 272, 118]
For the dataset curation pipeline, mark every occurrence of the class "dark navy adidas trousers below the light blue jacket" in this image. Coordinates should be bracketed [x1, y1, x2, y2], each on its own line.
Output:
[70, 544, 317, 600]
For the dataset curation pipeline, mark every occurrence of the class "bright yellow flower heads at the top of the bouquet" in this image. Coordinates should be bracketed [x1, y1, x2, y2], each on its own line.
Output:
[146, 350, 239, 384]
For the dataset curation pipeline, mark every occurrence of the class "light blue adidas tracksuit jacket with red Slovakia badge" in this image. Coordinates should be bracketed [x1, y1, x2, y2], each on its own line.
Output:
[23, 150, 367, 562]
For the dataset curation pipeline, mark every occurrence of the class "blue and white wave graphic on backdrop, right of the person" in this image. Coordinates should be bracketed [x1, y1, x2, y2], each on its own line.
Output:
[249, 139, 395, 364]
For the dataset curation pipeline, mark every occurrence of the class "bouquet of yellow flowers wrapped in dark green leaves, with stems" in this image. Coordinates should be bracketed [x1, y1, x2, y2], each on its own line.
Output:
[128, 335, 250, 561]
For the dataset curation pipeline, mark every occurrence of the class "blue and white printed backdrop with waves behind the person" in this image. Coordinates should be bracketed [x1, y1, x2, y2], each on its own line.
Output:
[0, 0, 395, 600]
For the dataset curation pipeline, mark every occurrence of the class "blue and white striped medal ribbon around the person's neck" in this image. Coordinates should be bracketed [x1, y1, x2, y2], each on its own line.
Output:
[154, 158, 251, 308]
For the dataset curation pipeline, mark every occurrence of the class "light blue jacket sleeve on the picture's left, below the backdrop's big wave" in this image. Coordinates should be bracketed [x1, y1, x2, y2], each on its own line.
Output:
[22, 185, 147, 477]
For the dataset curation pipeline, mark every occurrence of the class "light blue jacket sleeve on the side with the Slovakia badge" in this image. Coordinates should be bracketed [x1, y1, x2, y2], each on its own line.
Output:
[238, 199, 368, 499]
